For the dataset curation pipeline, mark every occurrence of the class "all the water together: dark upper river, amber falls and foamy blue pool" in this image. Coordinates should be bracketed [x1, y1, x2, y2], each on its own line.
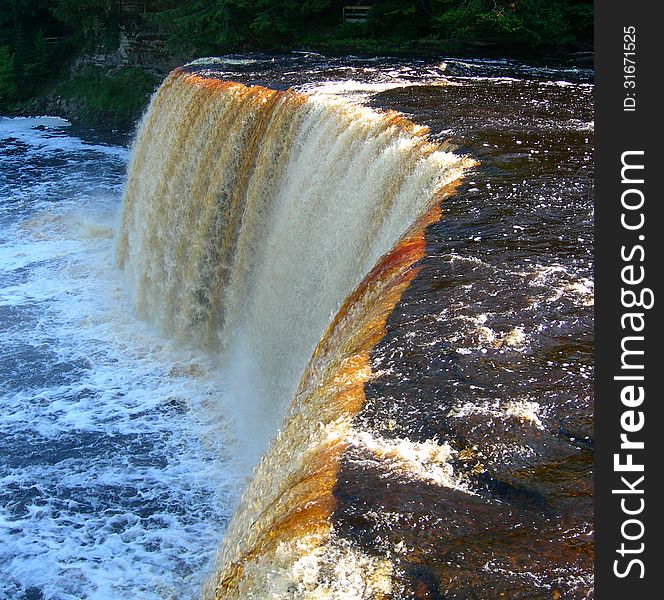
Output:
[0, 53, 593, 600]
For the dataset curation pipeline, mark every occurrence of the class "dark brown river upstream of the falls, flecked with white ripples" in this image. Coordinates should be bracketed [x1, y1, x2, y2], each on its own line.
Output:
[171, 56, 593, 599]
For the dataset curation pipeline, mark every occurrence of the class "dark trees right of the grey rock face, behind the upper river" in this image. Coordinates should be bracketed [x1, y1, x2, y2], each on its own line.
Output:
[155, 0, 593, 54]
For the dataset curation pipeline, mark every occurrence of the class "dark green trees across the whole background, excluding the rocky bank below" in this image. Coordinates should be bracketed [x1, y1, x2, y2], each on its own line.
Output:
[0, 0, 593, 108]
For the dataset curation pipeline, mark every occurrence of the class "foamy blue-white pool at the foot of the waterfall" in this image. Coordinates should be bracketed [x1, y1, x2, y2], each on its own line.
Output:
[0, 118, 240, 600]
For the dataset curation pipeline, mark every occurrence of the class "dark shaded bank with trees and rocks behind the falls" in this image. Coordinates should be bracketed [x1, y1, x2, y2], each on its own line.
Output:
[0, 0, 593, 130]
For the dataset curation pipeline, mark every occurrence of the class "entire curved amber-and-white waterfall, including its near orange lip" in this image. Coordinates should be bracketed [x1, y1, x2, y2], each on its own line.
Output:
[117, 70, 472, 599]
